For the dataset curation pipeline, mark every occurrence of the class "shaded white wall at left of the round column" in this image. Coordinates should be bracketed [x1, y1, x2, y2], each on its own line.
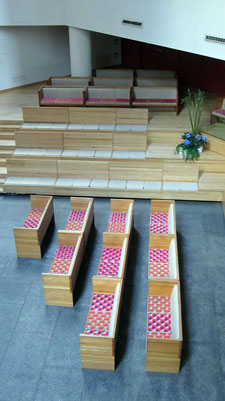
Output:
[0, 27, 70, 90]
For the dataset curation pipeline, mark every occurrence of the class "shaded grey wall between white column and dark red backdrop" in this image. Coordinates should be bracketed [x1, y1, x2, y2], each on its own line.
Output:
[91, 32, 122, 69]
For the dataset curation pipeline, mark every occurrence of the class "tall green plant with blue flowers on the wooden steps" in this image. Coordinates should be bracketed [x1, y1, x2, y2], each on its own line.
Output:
[176, 89, 208, 161]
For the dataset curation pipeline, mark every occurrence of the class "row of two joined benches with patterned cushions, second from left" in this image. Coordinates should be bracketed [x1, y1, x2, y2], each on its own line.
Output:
[42, 198, 94, 307]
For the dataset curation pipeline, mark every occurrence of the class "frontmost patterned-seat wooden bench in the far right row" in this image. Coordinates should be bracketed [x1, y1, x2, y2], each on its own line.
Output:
[146, 280, 182, 373]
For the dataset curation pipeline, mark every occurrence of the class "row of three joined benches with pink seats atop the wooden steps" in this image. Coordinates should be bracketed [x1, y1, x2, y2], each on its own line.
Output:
[38, 81, 178, 109]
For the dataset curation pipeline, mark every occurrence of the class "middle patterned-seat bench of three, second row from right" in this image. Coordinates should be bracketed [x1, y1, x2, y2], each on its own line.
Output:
[92, 232, 129, 280]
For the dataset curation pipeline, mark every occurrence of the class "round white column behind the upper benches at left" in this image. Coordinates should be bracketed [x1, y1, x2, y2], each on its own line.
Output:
[69, 27, 92, 77]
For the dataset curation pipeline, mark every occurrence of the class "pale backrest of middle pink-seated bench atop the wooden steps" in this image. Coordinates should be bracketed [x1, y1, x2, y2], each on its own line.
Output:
[88, 86, 130, 99]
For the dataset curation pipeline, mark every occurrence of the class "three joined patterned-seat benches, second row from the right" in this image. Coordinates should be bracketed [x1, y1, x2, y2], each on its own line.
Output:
[80, 199, 134, 370]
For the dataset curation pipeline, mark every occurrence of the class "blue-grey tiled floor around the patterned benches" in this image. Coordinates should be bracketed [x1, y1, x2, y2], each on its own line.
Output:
[0, 195, 225, 401]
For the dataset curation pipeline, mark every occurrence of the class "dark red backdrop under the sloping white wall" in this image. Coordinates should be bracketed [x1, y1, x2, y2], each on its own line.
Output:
[122, 39, 225, 97]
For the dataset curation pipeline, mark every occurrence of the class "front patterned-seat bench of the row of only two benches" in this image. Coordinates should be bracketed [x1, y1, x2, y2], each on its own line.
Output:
[42, 231, 85, 307]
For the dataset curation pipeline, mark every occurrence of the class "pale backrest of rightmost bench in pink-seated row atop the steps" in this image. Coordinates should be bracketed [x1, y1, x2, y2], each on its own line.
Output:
[133, 86, 177, 99]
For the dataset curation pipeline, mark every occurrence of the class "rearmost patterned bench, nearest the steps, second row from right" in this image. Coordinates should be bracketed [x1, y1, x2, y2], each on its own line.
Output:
[106, 199, 134, 235]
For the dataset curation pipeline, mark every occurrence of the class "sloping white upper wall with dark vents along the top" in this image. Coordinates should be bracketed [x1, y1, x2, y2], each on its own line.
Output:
[0, 0, 225, 60]
